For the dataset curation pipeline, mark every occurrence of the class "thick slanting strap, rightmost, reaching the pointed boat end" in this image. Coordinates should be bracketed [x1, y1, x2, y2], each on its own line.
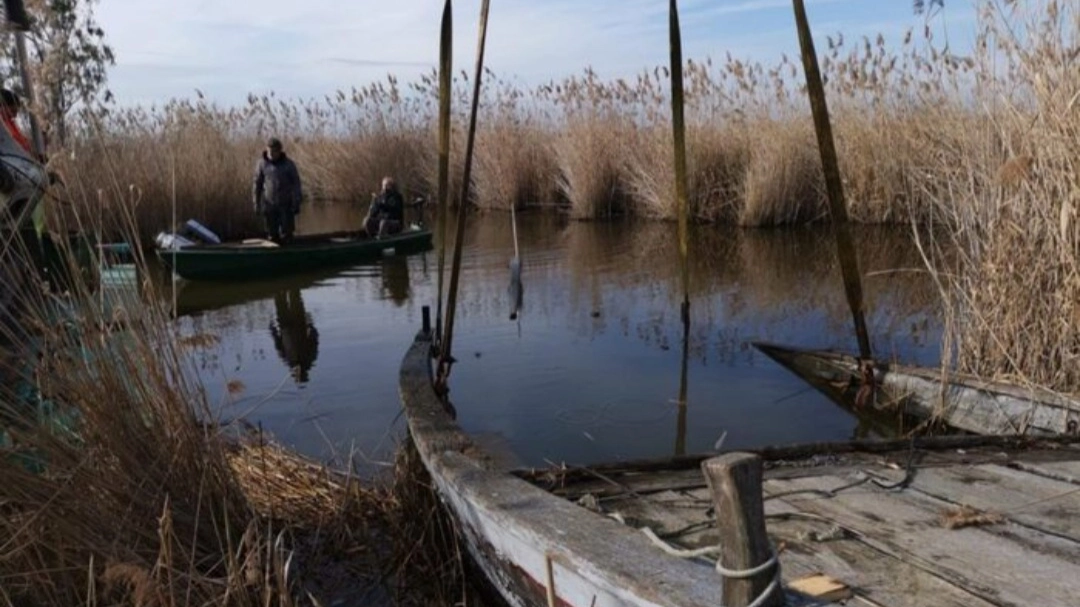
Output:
[793, 0, 873, 361]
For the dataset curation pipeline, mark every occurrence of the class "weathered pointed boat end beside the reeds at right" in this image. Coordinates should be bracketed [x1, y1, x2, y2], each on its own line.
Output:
[754, 342, 1080, 434]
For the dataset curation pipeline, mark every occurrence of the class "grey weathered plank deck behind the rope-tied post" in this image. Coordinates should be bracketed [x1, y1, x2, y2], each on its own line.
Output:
[517, 437, 1080, 607]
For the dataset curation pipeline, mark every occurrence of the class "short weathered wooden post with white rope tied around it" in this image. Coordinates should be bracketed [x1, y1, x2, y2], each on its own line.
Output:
[701, 453, 784, 607]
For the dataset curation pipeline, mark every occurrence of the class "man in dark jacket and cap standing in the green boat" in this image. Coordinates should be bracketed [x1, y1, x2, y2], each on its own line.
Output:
[252, 137, 301, 244]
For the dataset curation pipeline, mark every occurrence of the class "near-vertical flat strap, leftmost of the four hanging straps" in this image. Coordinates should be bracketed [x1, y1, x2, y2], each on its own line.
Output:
[435, 0, 454, 339]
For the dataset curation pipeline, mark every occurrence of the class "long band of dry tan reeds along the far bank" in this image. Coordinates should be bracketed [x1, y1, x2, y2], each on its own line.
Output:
[42, 0, 1036, 237]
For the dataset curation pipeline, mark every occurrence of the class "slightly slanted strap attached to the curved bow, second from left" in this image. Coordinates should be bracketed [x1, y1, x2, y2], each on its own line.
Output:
[435, 0, 491, 386]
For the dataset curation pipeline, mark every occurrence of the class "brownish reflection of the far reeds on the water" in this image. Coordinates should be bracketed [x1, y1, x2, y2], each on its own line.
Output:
[408, 214, 937, 359]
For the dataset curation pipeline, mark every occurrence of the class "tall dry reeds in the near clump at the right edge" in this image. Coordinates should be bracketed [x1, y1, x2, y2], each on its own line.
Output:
[926, 1, 1080, 392]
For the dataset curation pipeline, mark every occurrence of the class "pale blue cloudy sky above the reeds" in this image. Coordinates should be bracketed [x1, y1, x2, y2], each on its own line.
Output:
[96, 0, 974, 105]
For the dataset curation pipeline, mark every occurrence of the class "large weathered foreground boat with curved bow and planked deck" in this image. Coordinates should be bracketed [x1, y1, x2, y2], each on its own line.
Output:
[400, 317, 1080, 607]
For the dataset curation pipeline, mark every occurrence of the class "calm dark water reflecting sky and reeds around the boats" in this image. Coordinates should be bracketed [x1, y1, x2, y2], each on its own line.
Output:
[157, 206, 940, 472]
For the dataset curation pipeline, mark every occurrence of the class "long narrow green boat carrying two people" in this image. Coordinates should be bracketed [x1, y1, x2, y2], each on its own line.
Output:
[157, 225, 432, 281]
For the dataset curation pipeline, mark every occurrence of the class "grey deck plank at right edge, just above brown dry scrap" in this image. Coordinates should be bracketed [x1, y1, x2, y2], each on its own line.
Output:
[881, 466, 1080, 537]
